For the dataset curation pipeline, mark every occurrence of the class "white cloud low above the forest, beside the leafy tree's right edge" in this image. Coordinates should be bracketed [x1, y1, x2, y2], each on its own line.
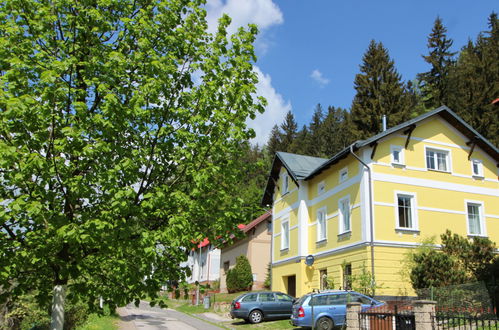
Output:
[247, 66, 291, 146]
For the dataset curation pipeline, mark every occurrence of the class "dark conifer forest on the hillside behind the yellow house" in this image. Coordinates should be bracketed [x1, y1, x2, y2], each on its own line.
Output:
[241, 13, 499, 222]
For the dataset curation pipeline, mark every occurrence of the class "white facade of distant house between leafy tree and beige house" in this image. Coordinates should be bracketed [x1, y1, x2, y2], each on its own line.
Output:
[180, 238, 221, 284]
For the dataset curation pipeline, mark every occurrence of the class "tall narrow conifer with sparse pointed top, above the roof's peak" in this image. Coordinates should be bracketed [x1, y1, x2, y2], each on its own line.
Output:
[418, 16, 455, 110]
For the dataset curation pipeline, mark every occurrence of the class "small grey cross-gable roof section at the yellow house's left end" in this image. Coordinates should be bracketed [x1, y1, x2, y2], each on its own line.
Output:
[262, 151, 327, 205]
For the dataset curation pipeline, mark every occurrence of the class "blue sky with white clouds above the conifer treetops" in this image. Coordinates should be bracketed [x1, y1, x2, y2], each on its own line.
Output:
[207, 0, 499, 144]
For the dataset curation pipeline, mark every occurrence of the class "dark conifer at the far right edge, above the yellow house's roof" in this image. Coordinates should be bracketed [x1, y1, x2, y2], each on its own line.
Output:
[449, 13, 499, 146]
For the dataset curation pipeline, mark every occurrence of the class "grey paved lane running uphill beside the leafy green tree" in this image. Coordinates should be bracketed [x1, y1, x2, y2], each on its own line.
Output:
[118, 301, 222, 330]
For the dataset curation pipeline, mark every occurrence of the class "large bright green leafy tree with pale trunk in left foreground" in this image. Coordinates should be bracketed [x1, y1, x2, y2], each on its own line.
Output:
[0, 0, 264, 328]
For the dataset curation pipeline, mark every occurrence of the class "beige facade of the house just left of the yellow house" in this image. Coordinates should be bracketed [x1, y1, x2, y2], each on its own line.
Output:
[220, 211, 272, 292]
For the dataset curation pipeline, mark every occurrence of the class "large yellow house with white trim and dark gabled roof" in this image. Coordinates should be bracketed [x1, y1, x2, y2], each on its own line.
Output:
[263, 107, 499, 296]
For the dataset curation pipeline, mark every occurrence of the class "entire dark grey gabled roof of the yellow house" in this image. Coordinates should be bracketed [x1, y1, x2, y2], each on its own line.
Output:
[262, 106, 499, 205]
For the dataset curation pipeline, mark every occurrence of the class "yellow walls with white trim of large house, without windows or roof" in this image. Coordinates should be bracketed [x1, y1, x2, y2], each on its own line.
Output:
[272, 116, 499, 296]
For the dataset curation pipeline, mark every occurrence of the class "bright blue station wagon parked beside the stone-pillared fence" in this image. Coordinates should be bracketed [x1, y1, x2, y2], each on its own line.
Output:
[291, 290, 385, 330]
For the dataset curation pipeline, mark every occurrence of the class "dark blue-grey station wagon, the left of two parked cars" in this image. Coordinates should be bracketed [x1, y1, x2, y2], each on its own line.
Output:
[230, 291, 295, 323]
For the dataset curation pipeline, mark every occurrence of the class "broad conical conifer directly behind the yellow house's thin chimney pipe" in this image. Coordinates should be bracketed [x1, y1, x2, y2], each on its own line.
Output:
[351, 40, 412, 139]
